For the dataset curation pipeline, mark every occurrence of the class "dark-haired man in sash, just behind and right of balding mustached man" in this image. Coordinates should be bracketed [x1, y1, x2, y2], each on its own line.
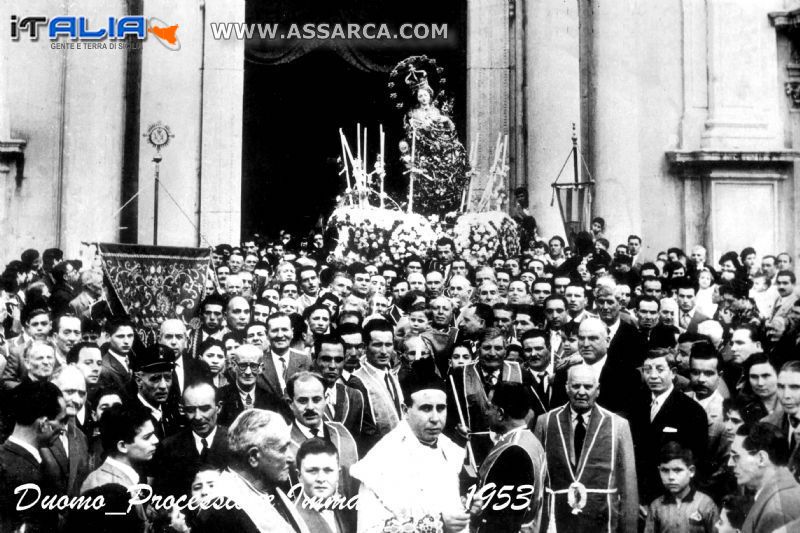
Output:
[314, 335, 377, 450]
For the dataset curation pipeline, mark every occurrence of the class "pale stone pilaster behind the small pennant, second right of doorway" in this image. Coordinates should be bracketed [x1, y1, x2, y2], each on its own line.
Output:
[524, 1, 581, 239]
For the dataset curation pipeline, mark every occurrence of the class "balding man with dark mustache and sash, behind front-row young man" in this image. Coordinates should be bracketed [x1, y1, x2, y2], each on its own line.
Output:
[286, 372, 358, 497]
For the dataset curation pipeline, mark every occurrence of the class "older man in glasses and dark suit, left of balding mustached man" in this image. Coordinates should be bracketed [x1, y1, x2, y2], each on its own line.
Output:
[218, 344, 288, 426]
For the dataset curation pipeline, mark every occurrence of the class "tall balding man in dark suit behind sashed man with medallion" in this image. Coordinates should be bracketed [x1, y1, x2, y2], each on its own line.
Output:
[553, 318, 641, 418]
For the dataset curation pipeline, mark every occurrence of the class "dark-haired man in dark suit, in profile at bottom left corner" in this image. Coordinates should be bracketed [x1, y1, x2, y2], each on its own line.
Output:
[0, 381, 67, 532]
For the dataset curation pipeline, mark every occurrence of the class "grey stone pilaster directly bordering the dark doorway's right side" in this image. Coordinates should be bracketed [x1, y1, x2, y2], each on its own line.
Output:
[466, 0, 509, 205]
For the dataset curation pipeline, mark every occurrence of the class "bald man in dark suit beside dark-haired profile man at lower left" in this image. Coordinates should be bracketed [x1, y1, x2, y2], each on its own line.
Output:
[39, 365, 89, 497]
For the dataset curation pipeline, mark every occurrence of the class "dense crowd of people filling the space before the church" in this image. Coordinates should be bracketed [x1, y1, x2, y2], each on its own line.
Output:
[0, 218, 800, 533]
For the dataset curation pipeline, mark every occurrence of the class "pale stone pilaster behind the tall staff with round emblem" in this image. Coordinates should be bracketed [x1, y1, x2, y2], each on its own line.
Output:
[138, 0, 203, 246]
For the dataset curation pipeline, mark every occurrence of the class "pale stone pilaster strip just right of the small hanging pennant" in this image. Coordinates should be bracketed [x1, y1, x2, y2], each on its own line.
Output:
[587, 0, 652, 247]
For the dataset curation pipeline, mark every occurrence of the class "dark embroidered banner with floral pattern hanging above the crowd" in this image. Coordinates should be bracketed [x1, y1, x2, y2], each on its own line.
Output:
[98, 243, 211, 345]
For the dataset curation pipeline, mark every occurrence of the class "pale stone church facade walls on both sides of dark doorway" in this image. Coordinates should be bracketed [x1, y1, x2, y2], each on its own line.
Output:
[0, 0, 800, 264]
